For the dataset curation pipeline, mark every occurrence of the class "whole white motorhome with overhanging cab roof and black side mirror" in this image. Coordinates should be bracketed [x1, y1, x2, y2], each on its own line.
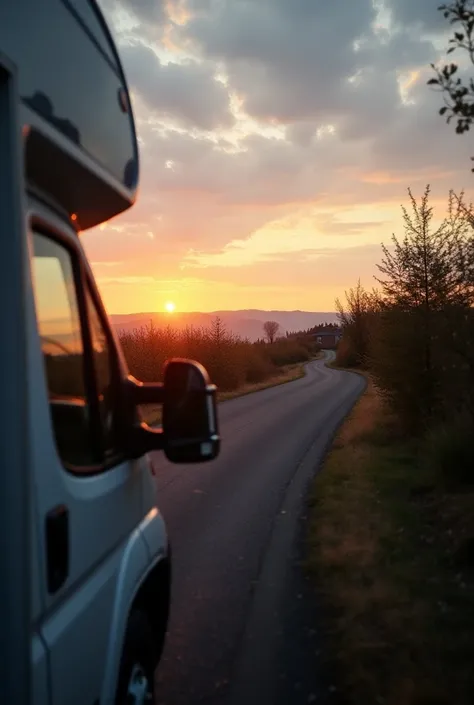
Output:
[0, 0, 219, 705]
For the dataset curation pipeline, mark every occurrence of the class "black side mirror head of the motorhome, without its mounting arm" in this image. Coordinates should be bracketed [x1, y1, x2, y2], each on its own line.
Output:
[163, 358, 220, 463]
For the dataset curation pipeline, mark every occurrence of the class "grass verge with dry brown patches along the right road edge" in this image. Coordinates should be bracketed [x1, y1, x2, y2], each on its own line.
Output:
[307, 380, 474, 705]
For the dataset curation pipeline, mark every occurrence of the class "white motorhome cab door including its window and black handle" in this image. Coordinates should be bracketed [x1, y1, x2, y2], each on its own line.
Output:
[30, 213, 142, 705]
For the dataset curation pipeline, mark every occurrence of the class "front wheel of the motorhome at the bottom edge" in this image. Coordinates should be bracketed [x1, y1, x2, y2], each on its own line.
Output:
[115, 609, 158, 705]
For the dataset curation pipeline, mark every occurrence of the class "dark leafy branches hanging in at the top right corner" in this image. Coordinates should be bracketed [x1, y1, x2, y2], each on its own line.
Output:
[428, 0, 474, 171]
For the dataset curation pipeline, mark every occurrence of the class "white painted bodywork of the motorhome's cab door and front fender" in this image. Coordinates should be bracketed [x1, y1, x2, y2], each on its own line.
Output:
[27, 195, 167, 705]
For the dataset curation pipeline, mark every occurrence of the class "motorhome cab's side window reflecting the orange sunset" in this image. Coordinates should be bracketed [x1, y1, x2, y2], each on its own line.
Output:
[32, 233, 116, 469]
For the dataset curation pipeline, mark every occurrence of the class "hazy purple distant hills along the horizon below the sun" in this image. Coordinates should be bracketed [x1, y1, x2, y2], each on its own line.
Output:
[110, 309, 337, 341]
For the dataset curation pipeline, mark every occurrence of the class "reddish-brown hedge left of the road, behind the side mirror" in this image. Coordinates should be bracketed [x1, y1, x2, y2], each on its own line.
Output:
[120, 317, 318, 391]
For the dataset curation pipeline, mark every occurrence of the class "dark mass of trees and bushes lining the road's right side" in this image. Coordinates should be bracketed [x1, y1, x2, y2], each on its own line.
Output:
[336, 187, 474, 480]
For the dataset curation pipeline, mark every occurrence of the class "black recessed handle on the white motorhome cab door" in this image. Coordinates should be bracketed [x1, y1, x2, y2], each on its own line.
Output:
[45, 504, 69, 594]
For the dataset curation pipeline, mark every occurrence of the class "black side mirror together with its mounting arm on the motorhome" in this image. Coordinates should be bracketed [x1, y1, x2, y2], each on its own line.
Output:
[121, 358, 220, 463]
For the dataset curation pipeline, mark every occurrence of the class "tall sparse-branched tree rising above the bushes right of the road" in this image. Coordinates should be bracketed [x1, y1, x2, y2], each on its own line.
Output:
[372, 186, 474, 426]
